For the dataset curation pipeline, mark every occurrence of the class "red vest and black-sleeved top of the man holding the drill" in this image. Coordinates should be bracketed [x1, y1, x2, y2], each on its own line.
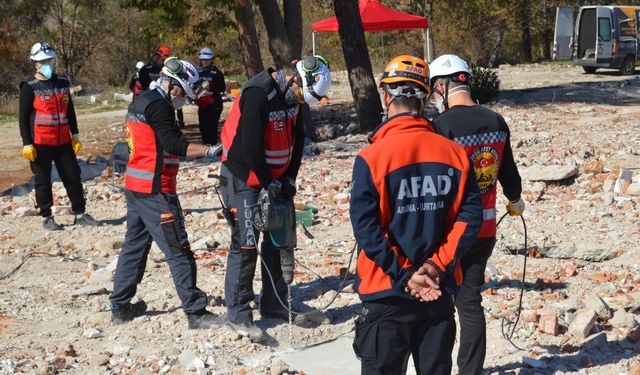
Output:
[220, 69, 304, 188]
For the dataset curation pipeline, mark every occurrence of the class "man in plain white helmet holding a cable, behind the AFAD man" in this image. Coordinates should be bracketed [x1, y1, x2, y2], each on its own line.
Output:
[430, 55, 525, 375]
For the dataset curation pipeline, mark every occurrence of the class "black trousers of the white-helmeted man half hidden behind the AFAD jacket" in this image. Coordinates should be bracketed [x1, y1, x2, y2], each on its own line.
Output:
[455, 237, 496, 375]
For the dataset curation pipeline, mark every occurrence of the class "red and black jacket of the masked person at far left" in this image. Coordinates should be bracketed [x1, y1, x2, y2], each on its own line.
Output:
[19, 74, 78, 146]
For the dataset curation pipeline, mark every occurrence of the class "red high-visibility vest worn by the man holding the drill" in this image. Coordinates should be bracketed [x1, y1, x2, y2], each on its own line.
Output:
[220, 70, 299, 187]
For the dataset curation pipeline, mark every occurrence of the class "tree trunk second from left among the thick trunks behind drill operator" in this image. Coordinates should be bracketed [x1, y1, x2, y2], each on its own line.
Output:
[256, 0, 294, 67]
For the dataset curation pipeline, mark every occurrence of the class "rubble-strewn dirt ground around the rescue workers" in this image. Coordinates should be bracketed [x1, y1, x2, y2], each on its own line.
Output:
[0, 64, 640, 375]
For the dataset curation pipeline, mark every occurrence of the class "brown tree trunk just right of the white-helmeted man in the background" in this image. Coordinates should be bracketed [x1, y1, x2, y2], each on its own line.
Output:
[234, 0, 264, 78]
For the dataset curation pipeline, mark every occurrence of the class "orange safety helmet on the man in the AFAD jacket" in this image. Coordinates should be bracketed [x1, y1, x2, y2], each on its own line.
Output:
[379, 55, 430, 93]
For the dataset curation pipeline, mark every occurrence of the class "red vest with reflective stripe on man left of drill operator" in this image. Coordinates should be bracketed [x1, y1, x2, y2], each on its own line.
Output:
[125, 90, 180, 194]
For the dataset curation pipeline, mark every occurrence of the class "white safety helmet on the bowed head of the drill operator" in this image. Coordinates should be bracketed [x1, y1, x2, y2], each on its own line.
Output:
[296, 55, 331, 104]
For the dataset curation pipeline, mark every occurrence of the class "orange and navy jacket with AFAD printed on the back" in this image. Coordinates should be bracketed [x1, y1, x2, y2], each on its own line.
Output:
[350, 113, 482, 301]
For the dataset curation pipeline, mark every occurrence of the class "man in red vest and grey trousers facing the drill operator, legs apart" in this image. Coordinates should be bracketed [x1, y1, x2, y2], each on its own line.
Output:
[110, 57, 217, 329]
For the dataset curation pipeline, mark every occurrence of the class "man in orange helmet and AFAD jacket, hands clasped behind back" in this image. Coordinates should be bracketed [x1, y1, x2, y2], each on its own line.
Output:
[350, 55, 482, 375]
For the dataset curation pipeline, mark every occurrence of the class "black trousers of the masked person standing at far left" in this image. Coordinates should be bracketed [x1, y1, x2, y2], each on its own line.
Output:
[31, 143, 85, 217]
